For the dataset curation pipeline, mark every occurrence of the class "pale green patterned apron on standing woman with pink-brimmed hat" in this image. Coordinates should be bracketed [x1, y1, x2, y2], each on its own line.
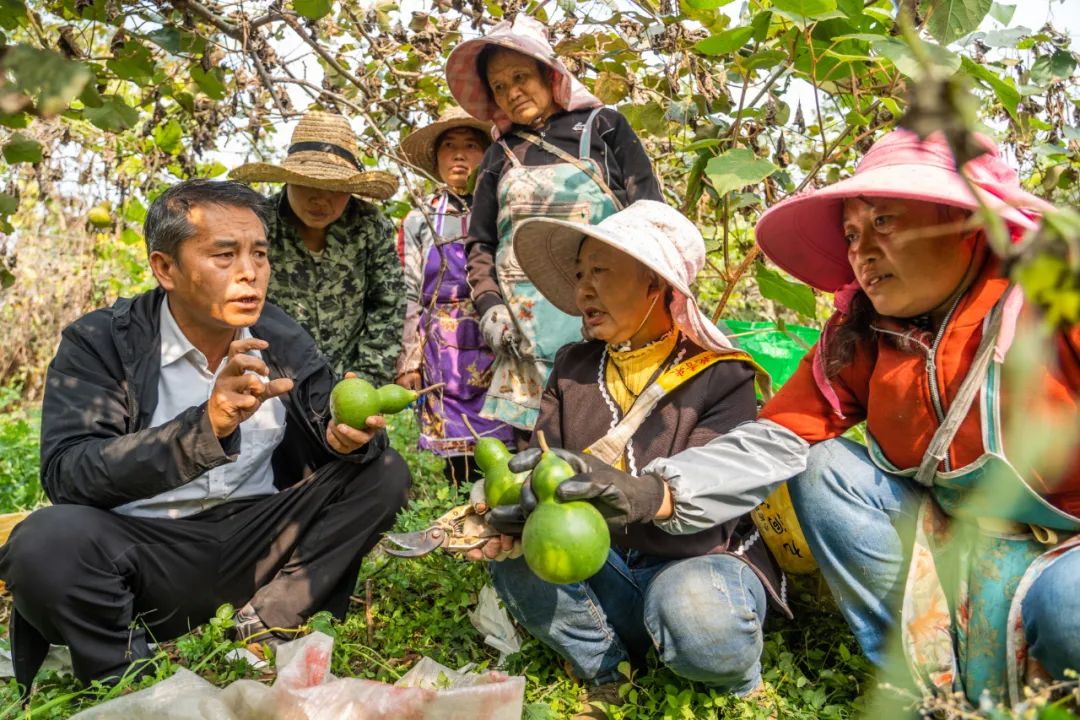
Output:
[482, 108, 622, 430]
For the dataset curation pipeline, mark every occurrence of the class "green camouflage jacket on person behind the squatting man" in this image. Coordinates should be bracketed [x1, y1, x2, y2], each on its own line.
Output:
[268, 189, 405, 385]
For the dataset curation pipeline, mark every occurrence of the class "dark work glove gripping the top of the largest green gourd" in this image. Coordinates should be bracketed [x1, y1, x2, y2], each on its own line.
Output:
[510, 448, 664, 530]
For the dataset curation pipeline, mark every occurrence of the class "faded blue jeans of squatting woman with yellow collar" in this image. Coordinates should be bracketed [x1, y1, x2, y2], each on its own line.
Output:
[489, 549, 766, 695]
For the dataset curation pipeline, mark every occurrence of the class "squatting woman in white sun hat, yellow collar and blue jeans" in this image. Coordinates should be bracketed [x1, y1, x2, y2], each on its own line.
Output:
[481, 201, 787, 718]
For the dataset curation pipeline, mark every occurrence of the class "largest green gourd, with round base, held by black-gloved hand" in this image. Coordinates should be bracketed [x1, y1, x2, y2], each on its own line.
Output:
[522, 431, 611, 585]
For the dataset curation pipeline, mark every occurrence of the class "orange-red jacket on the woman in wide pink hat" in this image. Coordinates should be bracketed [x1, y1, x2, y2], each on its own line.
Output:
[760, 263, 1080, 515]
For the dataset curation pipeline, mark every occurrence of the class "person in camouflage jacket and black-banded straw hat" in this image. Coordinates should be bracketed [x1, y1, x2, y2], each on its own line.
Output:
[230, 110, 405, 384]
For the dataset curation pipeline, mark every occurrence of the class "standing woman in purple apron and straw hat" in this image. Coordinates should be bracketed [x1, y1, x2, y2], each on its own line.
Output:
[397, 108, 511, 485]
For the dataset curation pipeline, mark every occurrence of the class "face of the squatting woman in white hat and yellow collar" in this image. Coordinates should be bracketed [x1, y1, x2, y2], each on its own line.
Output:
[575, 237, 666, 345]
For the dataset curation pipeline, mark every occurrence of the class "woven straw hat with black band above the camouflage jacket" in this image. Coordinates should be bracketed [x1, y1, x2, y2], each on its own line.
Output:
[229, 110, 397, 200]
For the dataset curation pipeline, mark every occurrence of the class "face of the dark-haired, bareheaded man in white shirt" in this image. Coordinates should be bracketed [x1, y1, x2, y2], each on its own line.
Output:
[150, 205, 270, 330]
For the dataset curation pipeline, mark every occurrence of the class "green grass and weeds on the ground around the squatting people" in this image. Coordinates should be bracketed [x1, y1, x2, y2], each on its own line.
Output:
[0, 405, 1070, 720]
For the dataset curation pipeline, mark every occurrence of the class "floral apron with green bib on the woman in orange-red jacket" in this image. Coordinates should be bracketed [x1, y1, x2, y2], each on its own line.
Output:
[868, 288, 1080, 704]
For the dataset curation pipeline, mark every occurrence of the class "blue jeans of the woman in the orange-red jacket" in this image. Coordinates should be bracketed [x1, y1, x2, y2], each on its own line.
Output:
[788, 438, 1080, 678]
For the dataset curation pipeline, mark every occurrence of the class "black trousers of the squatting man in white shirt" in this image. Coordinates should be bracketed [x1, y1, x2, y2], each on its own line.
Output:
[0, 449, 409, 682]
